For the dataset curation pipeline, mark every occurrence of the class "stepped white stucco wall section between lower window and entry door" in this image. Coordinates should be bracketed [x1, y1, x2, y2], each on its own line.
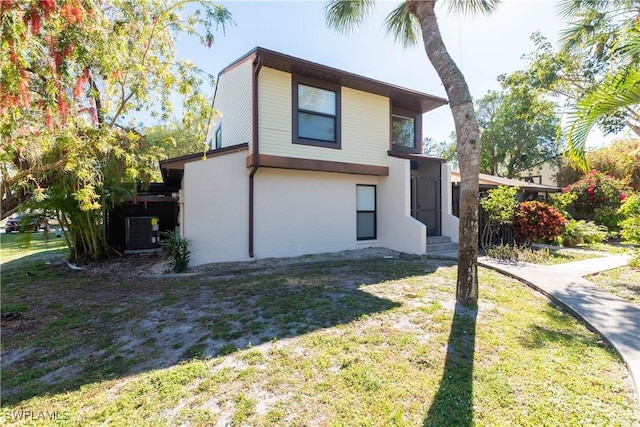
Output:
[378, 157, 427, 254]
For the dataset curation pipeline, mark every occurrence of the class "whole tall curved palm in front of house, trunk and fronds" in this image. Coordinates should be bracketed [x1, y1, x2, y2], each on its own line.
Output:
[325, 0, 500, 305]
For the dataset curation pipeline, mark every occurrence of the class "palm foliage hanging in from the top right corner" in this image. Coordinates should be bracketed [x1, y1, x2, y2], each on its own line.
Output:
[559, 0, 640, 169]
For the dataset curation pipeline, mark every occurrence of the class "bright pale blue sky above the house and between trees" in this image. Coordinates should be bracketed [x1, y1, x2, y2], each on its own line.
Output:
[172, 0, 608, 144]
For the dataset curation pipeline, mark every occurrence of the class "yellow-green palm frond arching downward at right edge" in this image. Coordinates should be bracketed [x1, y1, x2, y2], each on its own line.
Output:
[566, 68, 640, 169]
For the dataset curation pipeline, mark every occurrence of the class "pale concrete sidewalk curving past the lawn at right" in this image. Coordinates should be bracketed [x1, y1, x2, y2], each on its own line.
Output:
[430, 253, 640, 403]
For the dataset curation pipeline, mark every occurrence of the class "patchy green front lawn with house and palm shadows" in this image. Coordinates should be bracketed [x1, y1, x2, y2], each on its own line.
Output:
[1, 246, 640, 426]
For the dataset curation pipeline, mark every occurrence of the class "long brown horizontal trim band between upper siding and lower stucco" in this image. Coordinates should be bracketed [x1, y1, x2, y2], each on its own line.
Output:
[247, 154, 389, 176]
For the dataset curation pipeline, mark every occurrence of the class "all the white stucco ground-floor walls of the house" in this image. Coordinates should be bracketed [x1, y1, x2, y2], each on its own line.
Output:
[181, 155, 450, 266]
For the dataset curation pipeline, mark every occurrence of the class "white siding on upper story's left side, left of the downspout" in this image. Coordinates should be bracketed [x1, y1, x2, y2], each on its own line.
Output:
[207, 60, 253, 148]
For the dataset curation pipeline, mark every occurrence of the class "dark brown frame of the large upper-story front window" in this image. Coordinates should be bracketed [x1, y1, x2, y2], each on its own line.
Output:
[291, 75, 342, 150]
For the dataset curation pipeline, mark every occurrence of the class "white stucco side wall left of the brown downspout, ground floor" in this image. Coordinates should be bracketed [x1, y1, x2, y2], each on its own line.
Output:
[182, 151, 249, 266]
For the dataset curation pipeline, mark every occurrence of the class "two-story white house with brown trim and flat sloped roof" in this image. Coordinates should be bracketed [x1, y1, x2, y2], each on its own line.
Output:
[161, 48, 458, 265]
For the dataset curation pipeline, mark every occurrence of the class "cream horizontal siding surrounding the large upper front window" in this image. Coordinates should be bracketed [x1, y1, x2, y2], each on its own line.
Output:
[256, 67, 391, 166]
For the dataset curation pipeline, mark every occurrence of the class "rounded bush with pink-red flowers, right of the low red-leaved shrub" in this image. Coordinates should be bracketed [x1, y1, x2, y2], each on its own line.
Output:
[563, 170, 627, 229]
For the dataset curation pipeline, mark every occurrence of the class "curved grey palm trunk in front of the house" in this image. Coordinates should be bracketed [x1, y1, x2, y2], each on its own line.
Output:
[407, 0, 480, 305]
